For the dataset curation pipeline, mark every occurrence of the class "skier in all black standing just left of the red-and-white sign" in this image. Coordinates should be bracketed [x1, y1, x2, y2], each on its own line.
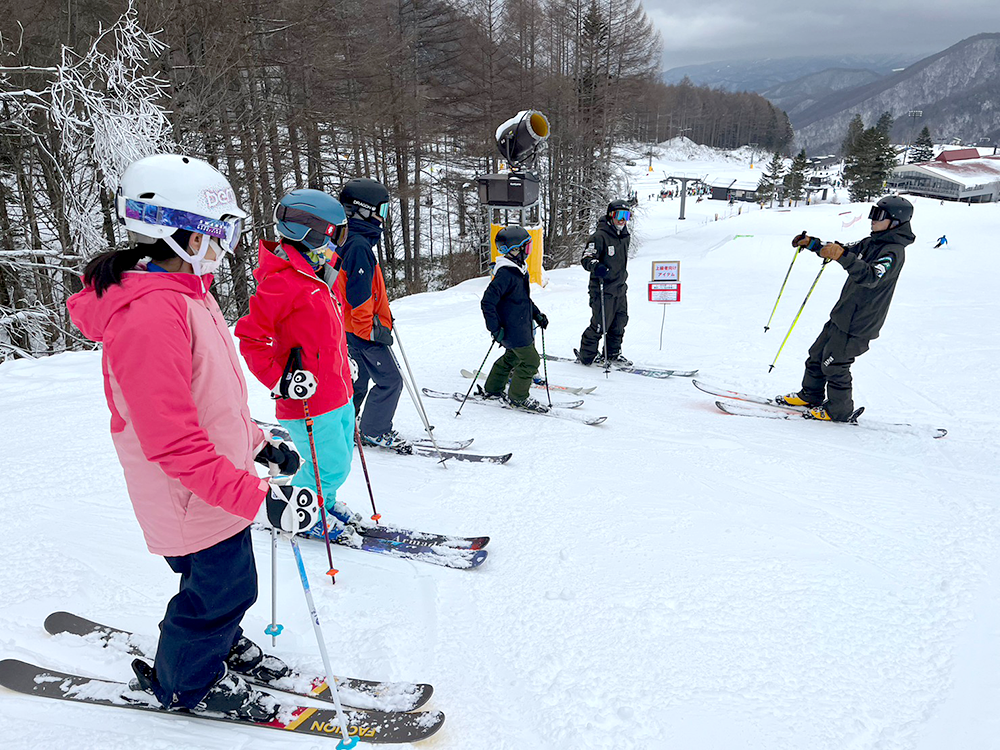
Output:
[576, 200, 632, 367]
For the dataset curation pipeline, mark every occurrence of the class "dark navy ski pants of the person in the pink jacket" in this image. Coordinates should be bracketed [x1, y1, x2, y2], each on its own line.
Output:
[153, 527, 257, 708]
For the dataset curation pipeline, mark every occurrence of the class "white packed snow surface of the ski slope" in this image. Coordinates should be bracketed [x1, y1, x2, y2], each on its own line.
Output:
[0, 149, 1000, 750]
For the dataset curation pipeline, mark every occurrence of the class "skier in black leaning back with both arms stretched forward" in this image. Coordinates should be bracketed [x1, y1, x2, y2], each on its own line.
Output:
[776, 195, 915, 422]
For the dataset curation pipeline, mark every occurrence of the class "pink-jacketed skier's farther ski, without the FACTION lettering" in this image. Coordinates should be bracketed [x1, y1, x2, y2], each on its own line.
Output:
[45, 612, 434, 713]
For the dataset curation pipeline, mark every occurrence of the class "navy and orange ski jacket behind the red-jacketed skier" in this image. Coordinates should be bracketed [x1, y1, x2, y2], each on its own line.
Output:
[336, 218, 392, 341]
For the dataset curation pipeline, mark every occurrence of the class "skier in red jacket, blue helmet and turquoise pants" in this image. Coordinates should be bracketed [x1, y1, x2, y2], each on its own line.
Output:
[235, 189, 360, 539]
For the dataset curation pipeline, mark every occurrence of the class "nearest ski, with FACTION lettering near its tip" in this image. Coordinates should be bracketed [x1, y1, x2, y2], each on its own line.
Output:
[0, 659, 444, 744]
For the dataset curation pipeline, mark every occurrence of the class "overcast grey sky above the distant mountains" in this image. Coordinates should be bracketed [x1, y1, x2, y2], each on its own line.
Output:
[642, 0, 1000, 70]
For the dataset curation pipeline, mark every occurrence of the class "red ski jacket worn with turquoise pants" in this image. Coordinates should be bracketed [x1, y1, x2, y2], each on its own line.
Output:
[235, 240, 354, 419]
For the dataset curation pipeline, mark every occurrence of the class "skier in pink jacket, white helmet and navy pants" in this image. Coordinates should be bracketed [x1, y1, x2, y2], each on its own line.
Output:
[67, 154, 318, 722]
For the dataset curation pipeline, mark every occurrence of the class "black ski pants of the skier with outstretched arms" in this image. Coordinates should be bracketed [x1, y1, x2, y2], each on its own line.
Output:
[799, 320, 868, 422]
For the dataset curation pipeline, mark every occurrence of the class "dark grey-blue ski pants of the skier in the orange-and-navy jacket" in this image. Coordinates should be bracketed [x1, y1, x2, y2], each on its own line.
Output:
[347, 333, 403, 437]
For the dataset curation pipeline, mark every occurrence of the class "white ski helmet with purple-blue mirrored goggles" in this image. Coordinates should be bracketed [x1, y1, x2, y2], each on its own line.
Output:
[115, 154, 247, 276]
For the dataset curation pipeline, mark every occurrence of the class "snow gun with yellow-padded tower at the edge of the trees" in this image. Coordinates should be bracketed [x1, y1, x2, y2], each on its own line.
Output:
[479, 109, 549, 284]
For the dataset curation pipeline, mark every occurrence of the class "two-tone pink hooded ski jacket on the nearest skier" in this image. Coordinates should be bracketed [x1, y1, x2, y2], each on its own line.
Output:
[67, 270, 267, 557]
